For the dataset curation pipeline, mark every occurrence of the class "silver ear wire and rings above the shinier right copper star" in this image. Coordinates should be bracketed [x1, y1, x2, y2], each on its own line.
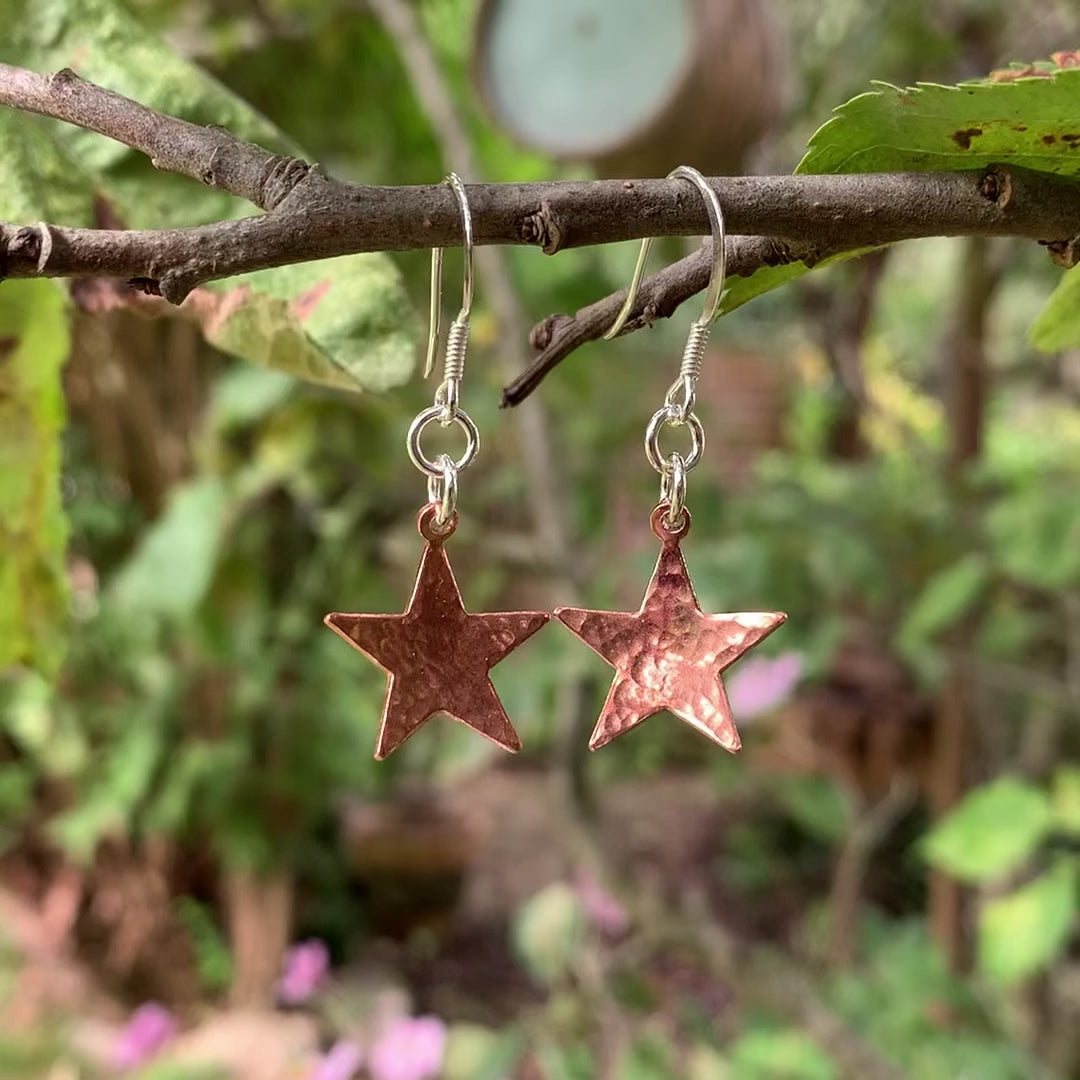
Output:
[604, 165, 727, 528]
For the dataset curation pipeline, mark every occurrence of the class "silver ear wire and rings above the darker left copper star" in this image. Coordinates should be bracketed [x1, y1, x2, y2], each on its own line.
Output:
[405, 173, 480, 526]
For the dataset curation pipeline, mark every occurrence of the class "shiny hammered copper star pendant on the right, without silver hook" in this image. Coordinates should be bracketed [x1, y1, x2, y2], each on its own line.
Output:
[554, 502, 787, 753]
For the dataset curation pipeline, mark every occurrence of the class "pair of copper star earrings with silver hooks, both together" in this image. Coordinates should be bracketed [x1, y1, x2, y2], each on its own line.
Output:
[325, 165, 787, 758]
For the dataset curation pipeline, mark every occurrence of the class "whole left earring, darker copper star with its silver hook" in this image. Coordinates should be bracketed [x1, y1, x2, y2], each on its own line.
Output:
[324, 173, 549, 759]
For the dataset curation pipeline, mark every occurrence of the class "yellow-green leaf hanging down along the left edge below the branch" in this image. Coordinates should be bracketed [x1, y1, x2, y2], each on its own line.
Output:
[0, 278, 68, 674]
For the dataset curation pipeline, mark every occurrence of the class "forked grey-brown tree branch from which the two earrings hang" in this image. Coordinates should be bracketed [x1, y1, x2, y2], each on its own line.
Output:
[0, 64, 1080, 404]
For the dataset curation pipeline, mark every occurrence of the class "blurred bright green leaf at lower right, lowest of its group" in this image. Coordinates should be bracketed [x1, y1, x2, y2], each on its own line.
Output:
[978, 860, 1077, 984]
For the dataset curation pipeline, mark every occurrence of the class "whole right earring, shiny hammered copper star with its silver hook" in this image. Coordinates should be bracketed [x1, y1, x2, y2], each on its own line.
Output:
[554, 165, 787, 753]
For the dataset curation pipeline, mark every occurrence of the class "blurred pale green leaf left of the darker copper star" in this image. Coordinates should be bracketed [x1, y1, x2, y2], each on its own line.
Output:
[110, 476, 227, 618]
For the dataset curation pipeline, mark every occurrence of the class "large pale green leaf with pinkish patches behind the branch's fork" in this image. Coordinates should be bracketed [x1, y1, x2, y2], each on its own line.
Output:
[0, 0, 416, 391]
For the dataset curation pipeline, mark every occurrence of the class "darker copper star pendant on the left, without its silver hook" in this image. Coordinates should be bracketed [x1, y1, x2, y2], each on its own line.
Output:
[324, 505, 549, 760]
